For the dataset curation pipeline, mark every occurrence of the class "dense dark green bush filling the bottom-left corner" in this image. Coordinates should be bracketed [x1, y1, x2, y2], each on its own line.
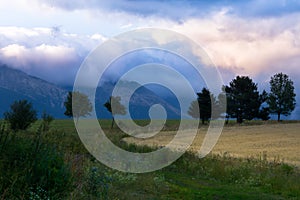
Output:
[0, 129, 72, 199]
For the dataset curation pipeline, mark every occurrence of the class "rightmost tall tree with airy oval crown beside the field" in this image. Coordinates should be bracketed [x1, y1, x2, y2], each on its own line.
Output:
[268, 73, 296, 121]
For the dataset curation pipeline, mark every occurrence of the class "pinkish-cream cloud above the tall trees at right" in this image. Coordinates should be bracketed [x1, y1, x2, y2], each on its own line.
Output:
[172, 13, 300, 79]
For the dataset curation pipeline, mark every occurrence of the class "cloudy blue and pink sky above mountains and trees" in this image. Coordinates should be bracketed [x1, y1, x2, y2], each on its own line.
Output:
[0, 0, 300, 118]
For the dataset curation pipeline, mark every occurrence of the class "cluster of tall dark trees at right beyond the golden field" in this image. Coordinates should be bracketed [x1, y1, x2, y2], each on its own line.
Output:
[188, 73, 296, 124]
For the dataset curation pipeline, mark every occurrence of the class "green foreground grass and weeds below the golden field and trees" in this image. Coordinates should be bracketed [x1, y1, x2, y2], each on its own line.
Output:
[0, 120, 300, 199]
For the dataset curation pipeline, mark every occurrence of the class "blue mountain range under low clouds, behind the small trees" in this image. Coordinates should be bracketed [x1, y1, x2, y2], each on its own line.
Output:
[0, 65, 180, 119]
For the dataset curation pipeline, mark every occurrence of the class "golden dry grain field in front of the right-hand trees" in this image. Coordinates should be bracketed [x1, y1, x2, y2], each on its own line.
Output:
[125, 123, 300, 166]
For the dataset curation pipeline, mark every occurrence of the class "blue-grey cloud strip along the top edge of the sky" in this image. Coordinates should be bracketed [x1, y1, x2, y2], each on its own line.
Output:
[44, 0, 300, 22]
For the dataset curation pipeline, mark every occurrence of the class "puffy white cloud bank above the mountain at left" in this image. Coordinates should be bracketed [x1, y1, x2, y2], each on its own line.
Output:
[0, 26, 106, 84]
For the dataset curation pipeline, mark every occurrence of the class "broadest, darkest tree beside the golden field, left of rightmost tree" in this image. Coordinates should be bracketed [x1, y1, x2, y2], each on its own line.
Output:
[225, 76, 261, 123]
